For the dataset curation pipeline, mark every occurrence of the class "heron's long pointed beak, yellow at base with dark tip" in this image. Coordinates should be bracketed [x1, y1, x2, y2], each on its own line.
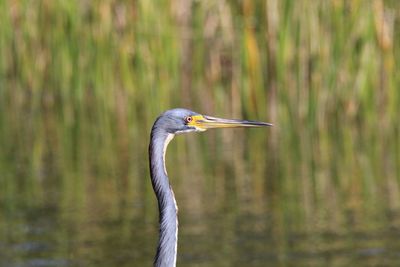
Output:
[192, 115, 272, 131]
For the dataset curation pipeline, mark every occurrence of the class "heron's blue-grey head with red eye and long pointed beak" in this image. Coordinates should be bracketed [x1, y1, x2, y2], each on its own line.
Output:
[156, 108, 272, 134]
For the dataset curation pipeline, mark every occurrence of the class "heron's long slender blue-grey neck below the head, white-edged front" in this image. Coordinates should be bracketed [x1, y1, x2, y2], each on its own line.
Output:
[149, 128, 178, 267]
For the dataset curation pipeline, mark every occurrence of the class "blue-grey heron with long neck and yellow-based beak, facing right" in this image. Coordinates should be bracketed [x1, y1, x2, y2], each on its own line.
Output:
[149, 108, 272, 267]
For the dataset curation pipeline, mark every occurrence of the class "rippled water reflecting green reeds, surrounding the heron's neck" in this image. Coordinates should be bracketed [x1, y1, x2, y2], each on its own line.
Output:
[0, 131, 400, 267]
